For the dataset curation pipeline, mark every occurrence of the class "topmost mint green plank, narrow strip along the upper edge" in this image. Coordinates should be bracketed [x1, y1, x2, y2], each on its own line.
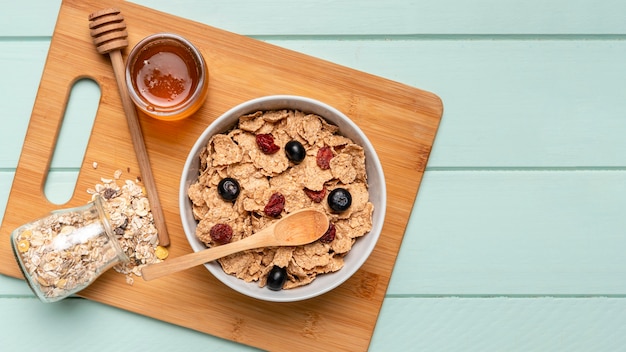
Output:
[6, 0, 626, 36]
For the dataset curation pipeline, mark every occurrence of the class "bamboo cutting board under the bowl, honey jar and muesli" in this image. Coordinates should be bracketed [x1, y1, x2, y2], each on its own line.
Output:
[0, 0, 443, 351]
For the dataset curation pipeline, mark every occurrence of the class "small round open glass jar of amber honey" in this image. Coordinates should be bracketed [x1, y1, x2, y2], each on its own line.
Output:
[126, 33, 209, 121]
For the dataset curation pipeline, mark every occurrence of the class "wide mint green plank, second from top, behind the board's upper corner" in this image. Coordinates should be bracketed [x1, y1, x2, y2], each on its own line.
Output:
[0, 40, 626, 168]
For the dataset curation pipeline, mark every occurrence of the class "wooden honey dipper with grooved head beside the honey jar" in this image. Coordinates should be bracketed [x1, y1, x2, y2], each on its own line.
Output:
[89, 8, 170, 246]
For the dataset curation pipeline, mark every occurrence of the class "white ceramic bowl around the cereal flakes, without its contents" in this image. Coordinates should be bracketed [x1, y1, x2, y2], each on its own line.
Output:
[179, 95, 387, 302]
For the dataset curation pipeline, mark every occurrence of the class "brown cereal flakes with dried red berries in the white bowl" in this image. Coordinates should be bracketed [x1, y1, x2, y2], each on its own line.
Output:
[188, 110, 374, 289]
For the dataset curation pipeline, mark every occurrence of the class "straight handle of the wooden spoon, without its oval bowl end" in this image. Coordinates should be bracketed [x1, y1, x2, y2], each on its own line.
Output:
[141, 226, 274, 281]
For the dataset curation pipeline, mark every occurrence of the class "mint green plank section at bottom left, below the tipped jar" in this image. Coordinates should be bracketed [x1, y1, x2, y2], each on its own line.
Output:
[0, 298, 257, 352]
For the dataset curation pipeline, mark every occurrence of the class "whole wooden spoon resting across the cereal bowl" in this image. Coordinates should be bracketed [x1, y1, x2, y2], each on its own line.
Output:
[141, 209, 329, 281]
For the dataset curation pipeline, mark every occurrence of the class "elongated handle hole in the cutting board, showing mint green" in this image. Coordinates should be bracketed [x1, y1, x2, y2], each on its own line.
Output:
[44, 78, 101, 205]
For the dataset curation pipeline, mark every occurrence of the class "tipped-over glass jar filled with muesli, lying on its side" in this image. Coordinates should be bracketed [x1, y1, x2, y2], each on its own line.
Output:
[11, 197, 129, 302]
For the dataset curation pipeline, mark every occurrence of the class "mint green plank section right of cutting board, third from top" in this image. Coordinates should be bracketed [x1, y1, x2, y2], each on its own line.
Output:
[388, 171, 626, 295]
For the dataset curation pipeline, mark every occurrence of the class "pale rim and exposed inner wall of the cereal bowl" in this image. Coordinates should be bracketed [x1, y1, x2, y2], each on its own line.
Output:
[179, 95, 387, 302]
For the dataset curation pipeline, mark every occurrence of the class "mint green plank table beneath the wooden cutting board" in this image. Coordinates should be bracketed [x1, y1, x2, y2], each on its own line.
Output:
[0, 0, 626, 351]
